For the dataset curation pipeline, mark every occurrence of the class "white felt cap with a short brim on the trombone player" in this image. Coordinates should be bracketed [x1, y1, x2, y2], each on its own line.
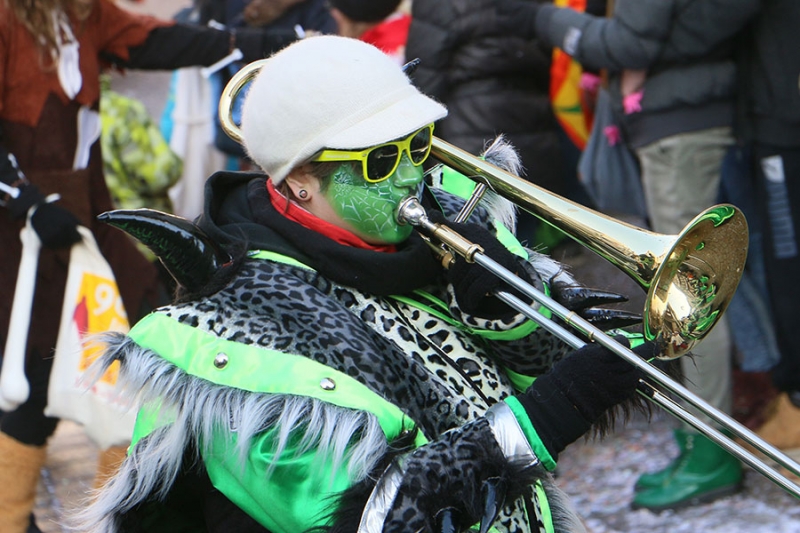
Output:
[242, 35, 447, 185]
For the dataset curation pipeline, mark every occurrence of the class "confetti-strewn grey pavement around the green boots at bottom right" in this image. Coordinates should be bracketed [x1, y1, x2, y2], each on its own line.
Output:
[559, 414, 800, 533]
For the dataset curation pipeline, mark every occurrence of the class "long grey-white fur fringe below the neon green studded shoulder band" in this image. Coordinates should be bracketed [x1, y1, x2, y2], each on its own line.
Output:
[73, 333, 388, 533]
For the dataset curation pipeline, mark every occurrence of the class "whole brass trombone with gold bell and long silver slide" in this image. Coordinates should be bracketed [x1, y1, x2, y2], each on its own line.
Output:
[219, 60, 800, 498]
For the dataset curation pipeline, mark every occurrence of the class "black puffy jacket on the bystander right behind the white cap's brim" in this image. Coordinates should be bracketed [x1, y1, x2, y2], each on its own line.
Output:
[406, 0, 564, 194]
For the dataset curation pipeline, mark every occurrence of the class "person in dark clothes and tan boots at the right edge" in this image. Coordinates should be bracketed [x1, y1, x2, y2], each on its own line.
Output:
[737, 0, 800, 455]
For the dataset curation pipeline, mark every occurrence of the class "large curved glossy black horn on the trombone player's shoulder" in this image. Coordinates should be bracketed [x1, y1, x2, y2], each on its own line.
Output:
[97, 209, 231, 291]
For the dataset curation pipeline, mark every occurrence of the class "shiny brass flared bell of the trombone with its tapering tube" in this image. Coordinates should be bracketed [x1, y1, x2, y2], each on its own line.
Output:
[431, 138, 748, 359]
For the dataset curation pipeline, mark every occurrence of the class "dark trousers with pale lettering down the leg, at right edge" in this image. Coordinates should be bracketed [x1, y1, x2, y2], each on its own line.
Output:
[754, 145, 800, 392]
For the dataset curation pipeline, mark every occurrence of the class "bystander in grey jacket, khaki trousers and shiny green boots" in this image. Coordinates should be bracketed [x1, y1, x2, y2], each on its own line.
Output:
[496, 0, 760, 511]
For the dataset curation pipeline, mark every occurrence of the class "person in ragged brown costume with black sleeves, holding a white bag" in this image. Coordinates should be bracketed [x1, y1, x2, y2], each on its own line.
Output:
[0, 0, 304, 533]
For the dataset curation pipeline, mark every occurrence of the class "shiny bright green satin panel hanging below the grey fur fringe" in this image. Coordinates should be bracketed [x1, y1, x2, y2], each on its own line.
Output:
[203, 432, 352, 533]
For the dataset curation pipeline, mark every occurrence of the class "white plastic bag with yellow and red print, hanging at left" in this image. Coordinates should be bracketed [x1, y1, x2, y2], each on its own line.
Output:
[45, 227, 136, 449]
